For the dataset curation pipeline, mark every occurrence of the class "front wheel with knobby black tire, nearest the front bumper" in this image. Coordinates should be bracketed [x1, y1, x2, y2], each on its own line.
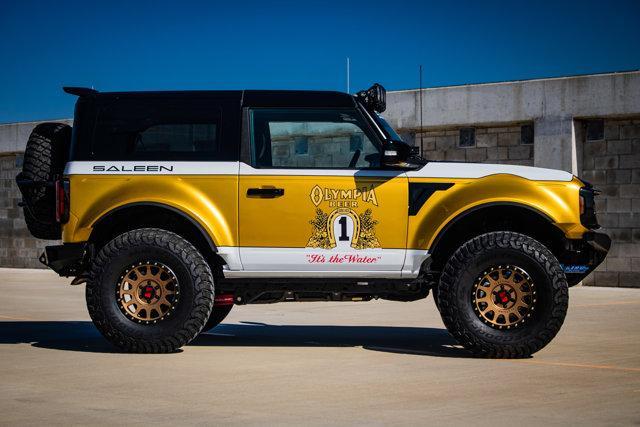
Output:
[437, 231, 569, 358]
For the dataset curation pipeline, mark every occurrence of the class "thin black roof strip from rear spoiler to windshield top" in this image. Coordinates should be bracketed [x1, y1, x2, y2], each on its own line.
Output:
[63, 87, 355, 108]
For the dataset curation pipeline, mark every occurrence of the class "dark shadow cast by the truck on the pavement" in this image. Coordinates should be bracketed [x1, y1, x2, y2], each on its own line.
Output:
[0, 321, 473, 357]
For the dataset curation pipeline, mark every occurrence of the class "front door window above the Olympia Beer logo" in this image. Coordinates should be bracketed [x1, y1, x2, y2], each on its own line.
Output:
[251, 109, 380, 169]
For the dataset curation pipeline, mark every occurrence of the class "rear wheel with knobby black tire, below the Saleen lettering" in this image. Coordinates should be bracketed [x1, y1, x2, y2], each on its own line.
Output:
[86, 228, 214, 353]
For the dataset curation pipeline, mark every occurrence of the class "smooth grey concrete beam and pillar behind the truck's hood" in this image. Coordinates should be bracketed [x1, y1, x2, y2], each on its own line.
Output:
[384, 71, 640, 174]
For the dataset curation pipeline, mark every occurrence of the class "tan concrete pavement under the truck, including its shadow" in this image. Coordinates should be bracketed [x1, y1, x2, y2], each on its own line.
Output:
[0, 269, 640, 426]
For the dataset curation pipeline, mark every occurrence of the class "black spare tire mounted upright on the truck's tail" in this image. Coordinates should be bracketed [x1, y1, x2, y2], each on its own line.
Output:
[17, 123, 71, 240]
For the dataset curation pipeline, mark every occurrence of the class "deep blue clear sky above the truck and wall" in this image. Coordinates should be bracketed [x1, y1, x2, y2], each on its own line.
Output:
[0, 0, 640, 123]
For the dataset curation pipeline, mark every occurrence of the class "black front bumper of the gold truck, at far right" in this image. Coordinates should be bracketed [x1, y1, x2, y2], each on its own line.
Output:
[558, 232, 611, 286]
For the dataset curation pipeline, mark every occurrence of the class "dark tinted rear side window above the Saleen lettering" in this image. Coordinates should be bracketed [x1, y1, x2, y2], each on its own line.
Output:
[91, 98, 225, 160]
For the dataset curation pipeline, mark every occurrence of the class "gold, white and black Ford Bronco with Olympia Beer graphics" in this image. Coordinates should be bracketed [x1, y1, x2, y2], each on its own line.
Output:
[16, 84, 610, 358]
